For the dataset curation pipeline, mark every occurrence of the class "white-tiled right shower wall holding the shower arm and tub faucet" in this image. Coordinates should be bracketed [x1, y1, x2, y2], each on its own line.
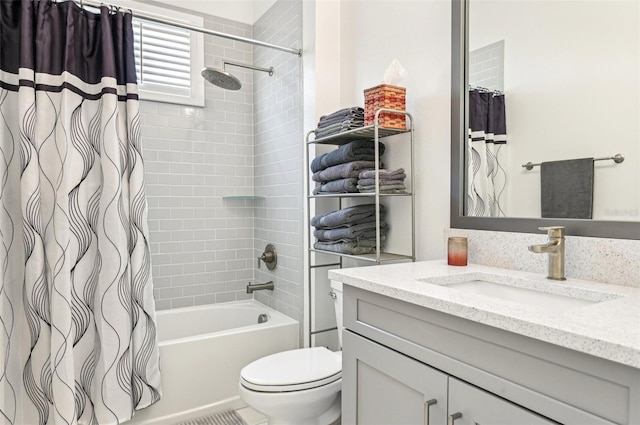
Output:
[253, 0, 304, 330]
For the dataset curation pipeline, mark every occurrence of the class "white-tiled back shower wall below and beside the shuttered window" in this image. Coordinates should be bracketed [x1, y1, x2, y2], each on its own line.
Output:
[140, 13, 255, 309]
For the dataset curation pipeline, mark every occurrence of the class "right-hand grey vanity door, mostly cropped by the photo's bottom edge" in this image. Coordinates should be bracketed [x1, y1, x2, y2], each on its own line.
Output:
[449, 378, 557, 425]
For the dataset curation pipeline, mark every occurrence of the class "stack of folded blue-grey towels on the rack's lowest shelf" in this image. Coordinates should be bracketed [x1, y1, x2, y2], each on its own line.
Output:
[311, 204, 388, 255]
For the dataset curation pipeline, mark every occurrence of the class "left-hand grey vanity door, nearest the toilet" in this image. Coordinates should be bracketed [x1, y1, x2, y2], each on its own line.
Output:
[342, 330, 447, 425]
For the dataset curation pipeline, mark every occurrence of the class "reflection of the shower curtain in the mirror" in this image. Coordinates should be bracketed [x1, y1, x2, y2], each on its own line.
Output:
[466, 89, 507, 217]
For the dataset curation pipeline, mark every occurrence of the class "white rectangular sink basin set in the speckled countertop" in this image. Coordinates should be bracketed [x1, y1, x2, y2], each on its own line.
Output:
[418, 273, 620, 311]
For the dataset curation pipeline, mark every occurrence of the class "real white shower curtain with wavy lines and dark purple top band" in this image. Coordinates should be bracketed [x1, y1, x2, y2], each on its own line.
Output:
[0, 0, 160, 425]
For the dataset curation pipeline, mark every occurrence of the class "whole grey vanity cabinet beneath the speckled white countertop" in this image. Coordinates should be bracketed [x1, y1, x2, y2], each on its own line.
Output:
[342, 285, 640, 425]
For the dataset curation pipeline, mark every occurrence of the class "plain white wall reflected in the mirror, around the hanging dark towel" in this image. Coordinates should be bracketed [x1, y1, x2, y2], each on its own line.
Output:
[469, 1, 640, 221]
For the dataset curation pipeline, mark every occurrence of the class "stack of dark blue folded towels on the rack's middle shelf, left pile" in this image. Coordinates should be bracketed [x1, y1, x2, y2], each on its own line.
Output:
[311, 140, 385, 195]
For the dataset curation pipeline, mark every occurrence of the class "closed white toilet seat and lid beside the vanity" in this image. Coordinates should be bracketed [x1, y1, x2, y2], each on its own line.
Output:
[240, 347, 342, 393]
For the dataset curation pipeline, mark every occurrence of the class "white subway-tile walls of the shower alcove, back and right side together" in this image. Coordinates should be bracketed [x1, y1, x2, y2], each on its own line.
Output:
[141, 0, 303, 320]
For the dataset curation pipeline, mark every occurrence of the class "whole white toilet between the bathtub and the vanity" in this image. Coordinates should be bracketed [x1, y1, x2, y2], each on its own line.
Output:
[240, 282, 342, 425]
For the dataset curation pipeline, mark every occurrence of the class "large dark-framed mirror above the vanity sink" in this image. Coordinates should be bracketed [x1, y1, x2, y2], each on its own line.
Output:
[451, 0, 640, 239]
